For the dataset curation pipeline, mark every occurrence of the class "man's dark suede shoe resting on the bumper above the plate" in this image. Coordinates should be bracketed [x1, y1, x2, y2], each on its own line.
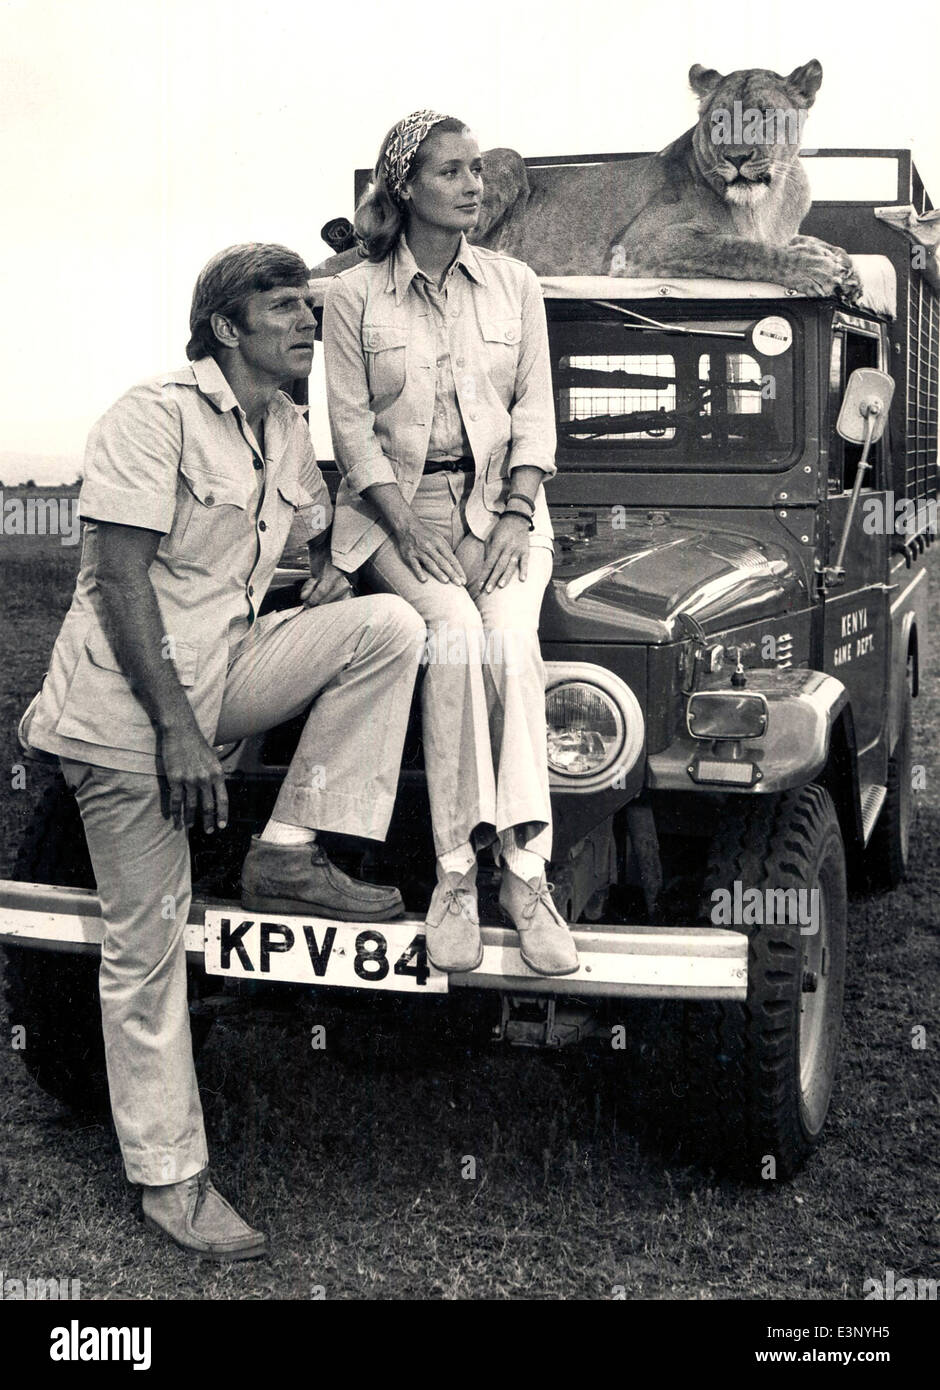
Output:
[242, 835, 405, 922]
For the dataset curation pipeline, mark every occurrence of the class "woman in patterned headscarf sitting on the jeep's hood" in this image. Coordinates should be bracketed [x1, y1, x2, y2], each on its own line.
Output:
[323, 111, 578, 974]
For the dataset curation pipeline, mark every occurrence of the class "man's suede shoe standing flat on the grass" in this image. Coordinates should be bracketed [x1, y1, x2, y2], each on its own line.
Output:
[142, 1168, 267, 1259]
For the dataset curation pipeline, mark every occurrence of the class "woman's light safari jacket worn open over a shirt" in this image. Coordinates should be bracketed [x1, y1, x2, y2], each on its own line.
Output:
[323, 236, 556, 573]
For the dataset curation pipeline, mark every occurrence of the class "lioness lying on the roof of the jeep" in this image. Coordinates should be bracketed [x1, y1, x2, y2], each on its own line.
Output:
[471, 58, 859, 299]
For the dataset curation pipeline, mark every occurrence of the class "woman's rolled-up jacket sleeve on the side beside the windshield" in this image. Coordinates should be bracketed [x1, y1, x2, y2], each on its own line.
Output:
[509, 267, 558, 478]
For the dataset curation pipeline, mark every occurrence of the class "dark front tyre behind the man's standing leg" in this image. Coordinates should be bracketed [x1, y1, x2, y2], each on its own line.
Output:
[4, 776, 211, 1115]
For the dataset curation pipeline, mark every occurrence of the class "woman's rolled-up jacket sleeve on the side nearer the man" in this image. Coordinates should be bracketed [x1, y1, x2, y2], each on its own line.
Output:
[323, 277, 395, 492]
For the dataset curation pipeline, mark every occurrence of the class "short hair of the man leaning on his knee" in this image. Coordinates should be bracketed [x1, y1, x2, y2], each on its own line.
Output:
[186, 242, 310, 361]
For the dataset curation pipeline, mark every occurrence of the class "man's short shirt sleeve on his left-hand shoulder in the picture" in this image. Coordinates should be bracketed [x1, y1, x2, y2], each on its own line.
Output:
[78, 382, 182, 535]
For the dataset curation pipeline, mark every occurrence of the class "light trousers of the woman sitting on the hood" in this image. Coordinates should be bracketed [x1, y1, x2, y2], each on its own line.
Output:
[364, 473, 552, 859]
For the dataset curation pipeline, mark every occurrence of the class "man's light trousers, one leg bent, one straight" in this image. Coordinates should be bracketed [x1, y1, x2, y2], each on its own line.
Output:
[60, 595, 424, 1186]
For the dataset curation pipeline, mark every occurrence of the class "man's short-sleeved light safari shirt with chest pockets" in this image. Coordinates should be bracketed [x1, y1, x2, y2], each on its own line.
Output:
[26, 357, 331, 773]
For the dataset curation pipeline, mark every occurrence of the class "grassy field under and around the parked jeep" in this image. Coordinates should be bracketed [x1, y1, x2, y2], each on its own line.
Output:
[0, 522, 940, 1300]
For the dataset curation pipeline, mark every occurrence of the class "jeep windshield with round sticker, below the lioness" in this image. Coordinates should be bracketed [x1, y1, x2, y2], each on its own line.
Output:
[549, 311, 794, 471]
